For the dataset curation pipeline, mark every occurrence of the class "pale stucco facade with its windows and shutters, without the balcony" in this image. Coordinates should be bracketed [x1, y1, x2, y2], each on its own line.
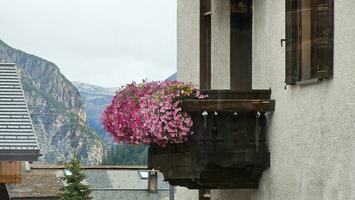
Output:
[176, 0, 355, 200]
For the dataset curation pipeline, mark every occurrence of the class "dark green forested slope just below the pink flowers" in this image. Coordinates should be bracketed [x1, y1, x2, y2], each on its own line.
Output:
[102, 144, 148, 165]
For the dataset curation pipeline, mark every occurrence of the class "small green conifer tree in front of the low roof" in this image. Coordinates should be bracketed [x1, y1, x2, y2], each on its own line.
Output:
[59, 156, 92, 200]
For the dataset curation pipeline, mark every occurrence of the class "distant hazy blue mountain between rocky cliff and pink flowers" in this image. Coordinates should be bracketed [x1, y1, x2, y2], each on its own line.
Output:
[73, 82, 118, 144]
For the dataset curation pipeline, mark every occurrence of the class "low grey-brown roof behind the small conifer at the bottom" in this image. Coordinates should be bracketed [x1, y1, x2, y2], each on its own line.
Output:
[14, 166, 169, 200]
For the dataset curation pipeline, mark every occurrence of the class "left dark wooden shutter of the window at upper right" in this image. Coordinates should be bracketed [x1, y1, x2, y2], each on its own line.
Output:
[285, 0, 301, 85]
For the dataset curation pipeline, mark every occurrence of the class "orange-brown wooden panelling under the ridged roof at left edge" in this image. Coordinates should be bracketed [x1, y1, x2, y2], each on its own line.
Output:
[0, 161, 22, 183]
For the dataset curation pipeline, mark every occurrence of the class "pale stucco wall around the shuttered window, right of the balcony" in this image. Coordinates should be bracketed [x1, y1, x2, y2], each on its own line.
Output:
[250, 0, 355, 200]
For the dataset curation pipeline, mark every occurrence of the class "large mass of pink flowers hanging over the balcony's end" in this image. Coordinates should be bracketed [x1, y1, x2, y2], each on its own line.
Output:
[102, 81, 206, 146]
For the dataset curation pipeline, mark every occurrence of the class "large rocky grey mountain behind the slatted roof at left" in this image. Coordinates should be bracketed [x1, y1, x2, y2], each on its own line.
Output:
[0, 40, 105, 164]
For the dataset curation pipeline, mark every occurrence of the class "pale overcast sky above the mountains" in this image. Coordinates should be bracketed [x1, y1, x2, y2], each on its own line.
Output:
[0, 0, 176, 87]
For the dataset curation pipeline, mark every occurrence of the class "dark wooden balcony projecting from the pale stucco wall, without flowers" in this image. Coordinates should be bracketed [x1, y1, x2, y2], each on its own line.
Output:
[148, 90, 275, 189]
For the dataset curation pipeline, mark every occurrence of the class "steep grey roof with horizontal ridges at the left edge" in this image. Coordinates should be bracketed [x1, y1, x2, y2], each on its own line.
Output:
[0, 63, 40, 161]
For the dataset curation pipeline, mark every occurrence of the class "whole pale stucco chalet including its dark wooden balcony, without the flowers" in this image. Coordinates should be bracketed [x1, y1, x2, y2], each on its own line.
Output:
[149, 0, 355, 200]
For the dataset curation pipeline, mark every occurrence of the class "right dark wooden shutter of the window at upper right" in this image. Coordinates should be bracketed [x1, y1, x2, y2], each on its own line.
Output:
[312, 0, 334, 78]
